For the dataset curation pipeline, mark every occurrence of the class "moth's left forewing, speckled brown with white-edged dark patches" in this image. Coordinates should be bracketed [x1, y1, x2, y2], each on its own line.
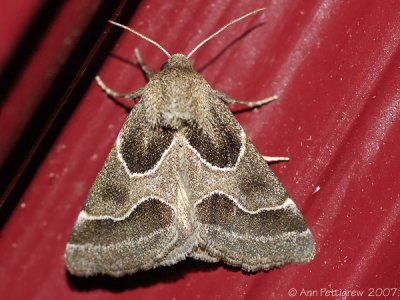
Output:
[65, 103, 178, 276]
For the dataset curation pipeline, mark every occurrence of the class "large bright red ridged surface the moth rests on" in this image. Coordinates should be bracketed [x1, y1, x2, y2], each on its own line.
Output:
[0, 0, 400, 299]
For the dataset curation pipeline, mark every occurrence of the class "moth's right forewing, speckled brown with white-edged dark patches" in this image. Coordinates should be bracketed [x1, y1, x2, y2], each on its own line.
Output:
[181, 99, 315, 271]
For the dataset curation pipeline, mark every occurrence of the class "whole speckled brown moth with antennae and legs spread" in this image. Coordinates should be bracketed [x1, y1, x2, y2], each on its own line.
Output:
[65, 9, 315, 276]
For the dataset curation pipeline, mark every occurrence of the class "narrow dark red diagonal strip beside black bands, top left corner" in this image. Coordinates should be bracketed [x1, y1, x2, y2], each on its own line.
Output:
[0, 1, 103, 166]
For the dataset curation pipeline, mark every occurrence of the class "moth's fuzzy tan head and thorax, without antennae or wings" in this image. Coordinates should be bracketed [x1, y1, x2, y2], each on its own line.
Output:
[142, 54, 211, 129]
